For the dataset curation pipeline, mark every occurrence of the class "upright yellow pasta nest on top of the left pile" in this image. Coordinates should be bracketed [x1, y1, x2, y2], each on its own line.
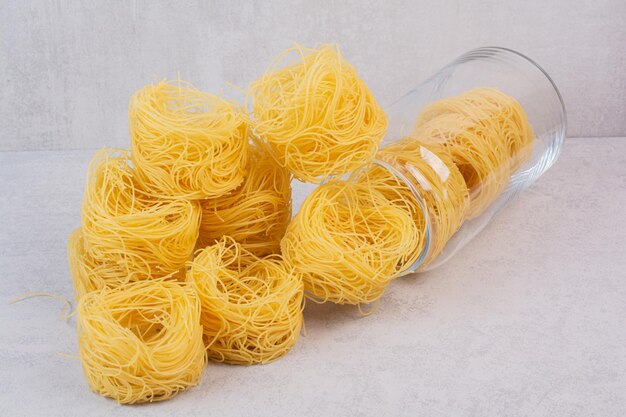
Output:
[128, 80, 248, 199]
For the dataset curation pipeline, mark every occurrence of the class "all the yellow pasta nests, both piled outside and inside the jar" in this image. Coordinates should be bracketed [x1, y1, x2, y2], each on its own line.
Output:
[69, 45, 532, 403]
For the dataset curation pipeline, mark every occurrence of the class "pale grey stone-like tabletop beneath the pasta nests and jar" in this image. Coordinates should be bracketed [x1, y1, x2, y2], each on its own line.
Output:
[0, 138, 626, 417]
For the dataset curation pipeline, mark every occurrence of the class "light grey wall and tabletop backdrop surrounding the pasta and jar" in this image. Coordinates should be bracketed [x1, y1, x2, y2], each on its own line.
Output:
[0, 0, 626, 417]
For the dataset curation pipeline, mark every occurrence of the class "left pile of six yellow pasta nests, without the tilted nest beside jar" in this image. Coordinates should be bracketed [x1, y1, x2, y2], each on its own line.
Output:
[69, 81, 303, 403]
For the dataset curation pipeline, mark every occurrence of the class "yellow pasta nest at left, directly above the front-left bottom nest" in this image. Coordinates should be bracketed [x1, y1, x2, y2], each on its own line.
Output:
[78, 149, 201, 292]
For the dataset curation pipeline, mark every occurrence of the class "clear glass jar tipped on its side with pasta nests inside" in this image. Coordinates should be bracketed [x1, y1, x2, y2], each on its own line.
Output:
[375, 47, 566, 274]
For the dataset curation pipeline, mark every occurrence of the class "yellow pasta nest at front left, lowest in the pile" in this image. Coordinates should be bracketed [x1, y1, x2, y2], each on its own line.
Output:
[78, 281, 206, 404]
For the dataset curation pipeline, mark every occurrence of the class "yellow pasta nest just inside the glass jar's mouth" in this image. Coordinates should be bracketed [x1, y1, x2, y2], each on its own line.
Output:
[356, 138, 469, 268]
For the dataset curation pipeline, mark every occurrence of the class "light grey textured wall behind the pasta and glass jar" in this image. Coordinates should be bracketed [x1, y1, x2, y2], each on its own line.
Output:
[0, 0, 626, 150]
